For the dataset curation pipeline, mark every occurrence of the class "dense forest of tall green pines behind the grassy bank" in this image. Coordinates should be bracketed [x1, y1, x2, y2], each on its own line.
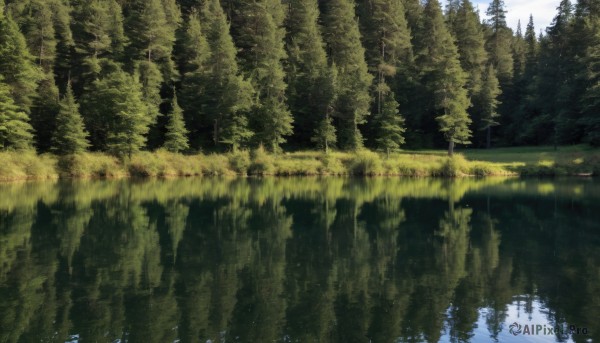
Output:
[0, 0, 600, 157]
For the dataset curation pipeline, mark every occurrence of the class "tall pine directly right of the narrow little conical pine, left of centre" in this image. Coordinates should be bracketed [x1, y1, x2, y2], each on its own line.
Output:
[201, 0, 254, 151]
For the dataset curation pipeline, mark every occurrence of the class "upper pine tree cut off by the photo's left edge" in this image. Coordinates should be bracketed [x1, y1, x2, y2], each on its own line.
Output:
[0, 3, 42, 113]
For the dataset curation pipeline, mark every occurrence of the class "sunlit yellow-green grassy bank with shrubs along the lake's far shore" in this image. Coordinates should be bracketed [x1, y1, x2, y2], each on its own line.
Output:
[0, 146, 600, 181]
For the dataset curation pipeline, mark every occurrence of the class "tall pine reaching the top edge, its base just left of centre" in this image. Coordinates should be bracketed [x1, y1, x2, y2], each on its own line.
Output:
[227, 0, 293, 151]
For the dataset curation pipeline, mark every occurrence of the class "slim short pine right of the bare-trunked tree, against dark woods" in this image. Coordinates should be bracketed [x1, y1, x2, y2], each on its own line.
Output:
[480, 64, 502, 149]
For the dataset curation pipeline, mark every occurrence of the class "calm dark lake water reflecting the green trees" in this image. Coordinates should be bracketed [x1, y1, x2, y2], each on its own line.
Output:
[0, 178, 600, 343]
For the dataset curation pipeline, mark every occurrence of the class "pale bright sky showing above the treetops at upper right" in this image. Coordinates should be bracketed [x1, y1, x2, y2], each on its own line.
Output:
[473, 0, 560, 33]
